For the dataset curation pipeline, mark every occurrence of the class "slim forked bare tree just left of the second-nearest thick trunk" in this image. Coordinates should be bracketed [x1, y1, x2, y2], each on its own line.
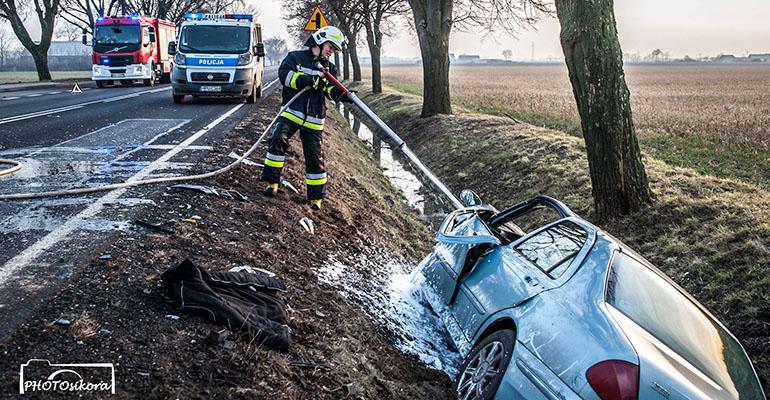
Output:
[359, 0, 408, 93]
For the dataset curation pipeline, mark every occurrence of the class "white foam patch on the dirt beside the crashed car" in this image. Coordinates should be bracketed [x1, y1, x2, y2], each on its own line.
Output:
[318, 254, 462, 378]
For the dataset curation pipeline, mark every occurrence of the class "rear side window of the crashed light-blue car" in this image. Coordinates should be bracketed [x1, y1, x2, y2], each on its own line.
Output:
[515, 221, 588, 279]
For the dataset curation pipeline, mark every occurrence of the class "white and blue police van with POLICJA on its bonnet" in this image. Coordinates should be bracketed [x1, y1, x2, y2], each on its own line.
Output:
[168, 13, 265, 103]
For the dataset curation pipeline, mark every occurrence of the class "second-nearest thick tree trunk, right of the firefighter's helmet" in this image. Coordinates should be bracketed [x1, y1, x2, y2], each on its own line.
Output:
[409, 0, 453, 117]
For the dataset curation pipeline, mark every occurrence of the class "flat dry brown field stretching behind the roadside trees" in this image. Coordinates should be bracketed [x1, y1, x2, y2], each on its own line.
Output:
[368, 65, 770, 188]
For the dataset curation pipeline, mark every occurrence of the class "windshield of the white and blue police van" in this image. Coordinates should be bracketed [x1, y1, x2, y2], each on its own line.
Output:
[179, 25, 250, 54]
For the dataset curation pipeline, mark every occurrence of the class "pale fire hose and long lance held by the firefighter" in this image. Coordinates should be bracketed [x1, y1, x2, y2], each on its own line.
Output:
[0, 63, 463, 208]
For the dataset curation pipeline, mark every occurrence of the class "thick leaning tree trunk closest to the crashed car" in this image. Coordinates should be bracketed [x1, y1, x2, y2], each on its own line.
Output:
[556, 0, 652, 221]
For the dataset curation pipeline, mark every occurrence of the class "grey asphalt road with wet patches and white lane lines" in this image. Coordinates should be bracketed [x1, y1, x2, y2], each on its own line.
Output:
[0, 69, 280, 339]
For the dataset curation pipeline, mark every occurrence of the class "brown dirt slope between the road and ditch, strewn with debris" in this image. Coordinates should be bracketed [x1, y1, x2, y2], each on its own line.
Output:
[0, 95, 450, 399]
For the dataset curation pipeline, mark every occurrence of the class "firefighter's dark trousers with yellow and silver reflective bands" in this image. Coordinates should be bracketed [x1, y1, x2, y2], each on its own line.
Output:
[262, 117, 327, 200]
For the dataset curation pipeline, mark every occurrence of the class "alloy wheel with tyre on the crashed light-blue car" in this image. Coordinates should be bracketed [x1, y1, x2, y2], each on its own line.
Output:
[455, 329, 516, 400]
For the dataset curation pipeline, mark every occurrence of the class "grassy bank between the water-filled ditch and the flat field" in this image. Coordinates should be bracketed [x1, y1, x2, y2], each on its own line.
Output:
[358, 83, 770, 395]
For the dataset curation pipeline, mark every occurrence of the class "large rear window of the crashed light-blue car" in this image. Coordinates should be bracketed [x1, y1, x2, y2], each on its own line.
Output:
[606, 253, 762, 399]
